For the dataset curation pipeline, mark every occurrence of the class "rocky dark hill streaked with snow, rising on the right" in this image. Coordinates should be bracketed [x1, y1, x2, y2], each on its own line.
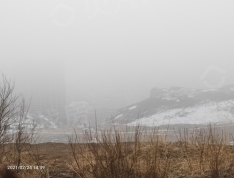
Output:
[105, 86, 234, 126]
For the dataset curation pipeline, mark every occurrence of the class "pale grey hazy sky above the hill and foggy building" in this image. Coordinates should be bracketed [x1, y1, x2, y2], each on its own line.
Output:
[0, 0, 234, 105]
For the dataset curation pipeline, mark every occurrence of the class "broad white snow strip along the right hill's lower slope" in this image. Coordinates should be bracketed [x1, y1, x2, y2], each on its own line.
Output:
[127, 100, 234, 126]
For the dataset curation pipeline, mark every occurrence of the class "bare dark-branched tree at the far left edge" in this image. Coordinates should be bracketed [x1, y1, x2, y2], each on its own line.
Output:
[0, 74, 36, 166]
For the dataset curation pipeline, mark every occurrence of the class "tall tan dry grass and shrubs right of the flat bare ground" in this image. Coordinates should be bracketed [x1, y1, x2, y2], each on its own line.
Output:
[69, 126, 234, 178]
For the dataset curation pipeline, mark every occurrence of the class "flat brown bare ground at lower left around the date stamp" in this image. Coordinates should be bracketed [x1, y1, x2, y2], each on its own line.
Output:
[5, 143, 73, 178]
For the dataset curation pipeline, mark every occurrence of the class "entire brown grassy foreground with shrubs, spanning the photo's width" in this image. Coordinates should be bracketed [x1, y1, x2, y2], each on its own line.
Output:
[4, 126, 234, 178]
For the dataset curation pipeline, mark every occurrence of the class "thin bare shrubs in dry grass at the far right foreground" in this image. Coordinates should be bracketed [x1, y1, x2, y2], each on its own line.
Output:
[177, 125, 233, 178]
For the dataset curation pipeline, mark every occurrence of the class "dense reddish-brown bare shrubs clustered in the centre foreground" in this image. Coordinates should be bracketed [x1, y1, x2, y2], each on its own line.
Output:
[69, 127, 170, 178]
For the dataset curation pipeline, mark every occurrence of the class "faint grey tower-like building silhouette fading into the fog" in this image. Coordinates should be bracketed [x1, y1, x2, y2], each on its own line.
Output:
[30, 66, 66, 123]
